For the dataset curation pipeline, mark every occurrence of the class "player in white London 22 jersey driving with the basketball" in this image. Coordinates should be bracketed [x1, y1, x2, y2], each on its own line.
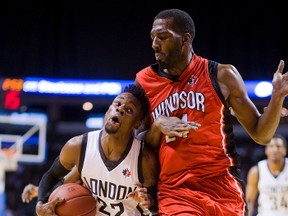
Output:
[36, 85, 158, 216]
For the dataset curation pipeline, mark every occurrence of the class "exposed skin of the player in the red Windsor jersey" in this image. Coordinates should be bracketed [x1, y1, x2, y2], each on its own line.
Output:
[135, 18, 288, 148]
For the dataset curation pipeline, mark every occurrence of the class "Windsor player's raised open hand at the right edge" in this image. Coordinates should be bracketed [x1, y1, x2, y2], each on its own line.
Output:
[272, 60, 288, 97]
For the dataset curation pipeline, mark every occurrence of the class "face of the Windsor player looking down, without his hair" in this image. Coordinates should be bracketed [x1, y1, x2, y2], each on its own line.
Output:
[150, 19, 183, 70]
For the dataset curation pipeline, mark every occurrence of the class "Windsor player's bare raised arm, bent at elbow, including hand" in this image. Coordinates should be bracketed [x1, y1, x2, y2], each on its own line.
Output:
[217, 62, 288, 144]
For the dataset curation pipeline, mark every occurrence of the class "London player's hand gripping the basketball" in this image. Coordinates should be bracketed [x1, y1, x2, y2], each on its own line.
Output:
[36, 197, 65, 216]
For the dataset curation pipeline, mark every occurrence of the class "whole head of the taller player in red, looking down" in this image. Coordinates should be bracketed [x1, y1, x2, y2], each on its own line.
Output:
[150, 9, 195, 69]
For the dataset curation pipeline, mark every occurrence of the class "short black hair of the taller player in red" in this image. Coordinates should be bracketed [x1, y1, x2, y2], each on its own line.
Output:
[154, 9, 195, 41]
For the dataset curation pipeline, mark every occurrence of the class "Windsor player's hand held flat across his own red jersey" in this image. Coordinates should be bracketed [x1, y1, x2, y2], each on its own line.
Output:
[155, 116, 201, 138]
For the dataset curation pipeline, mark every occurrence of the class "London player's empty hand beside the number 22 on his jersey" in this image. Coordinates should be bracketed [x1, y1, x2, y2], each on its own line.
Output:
[128, 184, 154, 209]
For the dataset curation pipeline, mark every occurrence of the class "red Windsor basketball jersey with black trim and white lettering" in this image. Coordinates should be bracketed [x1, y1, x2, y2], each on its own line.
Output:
[136, 54, 235, 189]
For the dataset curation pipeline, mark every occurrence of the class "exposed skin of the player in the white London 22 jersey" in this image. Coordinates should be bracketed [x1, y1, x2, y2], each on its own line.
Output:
[36, 92, 158, 216]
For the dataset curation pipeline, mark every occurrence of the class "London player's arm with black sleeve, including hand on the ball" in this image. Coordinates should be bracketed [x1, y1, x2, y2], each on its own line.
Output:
[36, 135, 83, 216]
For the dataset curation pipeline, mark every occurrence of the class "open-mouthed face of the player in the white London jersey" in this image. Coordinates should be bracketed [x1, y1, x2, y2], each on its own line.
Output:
[104, 92, 142, 134]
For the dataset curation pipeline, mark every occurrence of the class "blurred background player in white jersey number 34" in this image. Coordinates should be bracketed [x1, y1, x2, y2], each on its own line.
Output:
[246, 134, 288, 216]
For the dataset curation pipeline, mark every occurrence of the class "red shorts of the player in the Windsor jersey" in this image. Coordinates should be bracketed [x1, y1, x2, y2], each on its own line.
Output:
[158, 171, 247, 216]
